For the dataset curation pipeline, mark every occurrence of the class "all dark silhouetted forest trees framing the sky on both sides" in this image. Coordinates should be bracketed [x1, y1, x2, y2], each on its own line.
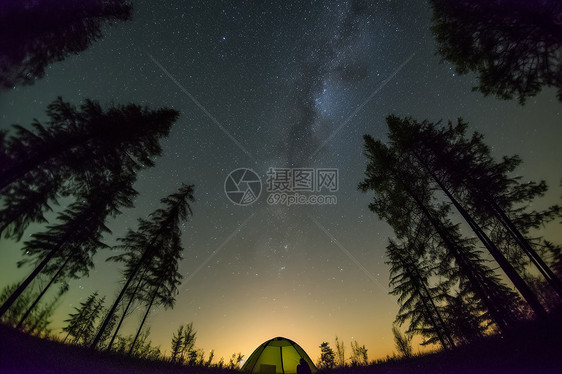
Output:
[0, 0, 562, 368]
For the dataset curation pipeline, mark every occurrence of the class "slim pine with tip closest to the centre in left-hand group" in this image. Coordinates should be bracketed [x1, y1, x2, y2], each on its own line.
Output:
[91, 185, 194, 348]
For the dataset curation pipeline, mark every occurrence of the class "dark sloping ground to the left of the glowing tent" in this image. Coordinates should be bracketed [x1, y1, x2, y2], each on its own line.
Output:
[0, 324, 235, 374]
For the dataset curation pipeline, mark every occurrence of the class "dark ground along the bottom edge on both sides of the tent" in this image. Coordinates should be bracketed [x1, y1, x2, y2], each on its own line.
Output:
[0, 314, 562, 374]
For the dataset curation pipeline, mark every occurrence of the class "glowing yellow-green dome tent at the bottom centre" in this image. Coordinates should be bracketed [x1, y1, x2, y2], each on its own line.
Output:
[242, 336, 317, 374]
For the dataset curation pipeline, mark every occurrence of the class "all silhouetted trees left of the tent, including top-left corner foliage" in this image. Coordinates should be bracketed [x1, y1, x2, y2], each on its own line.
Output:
[0, 0, 242, 368]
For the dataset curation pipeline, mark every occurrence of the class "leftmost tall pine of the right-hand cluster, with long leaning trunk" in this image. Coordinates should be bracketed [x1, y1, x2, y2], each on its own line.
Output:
[359, 135, 511, 331]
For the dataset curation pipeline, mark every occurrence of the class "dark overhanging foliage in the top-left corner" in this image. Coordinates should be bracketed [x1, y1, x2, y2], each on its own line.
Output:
[0, 0, 132, 89]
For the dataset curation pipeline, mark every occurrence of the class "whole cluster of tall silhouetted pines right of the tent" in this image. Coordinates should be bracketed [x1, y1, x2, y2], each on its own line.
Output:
[359, 115, 562, 349]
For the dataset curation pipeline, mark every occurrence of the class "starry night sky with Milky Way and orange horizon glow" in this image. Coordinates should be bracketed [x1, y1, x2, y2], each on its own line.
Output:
[0, 0, 562, 361]
